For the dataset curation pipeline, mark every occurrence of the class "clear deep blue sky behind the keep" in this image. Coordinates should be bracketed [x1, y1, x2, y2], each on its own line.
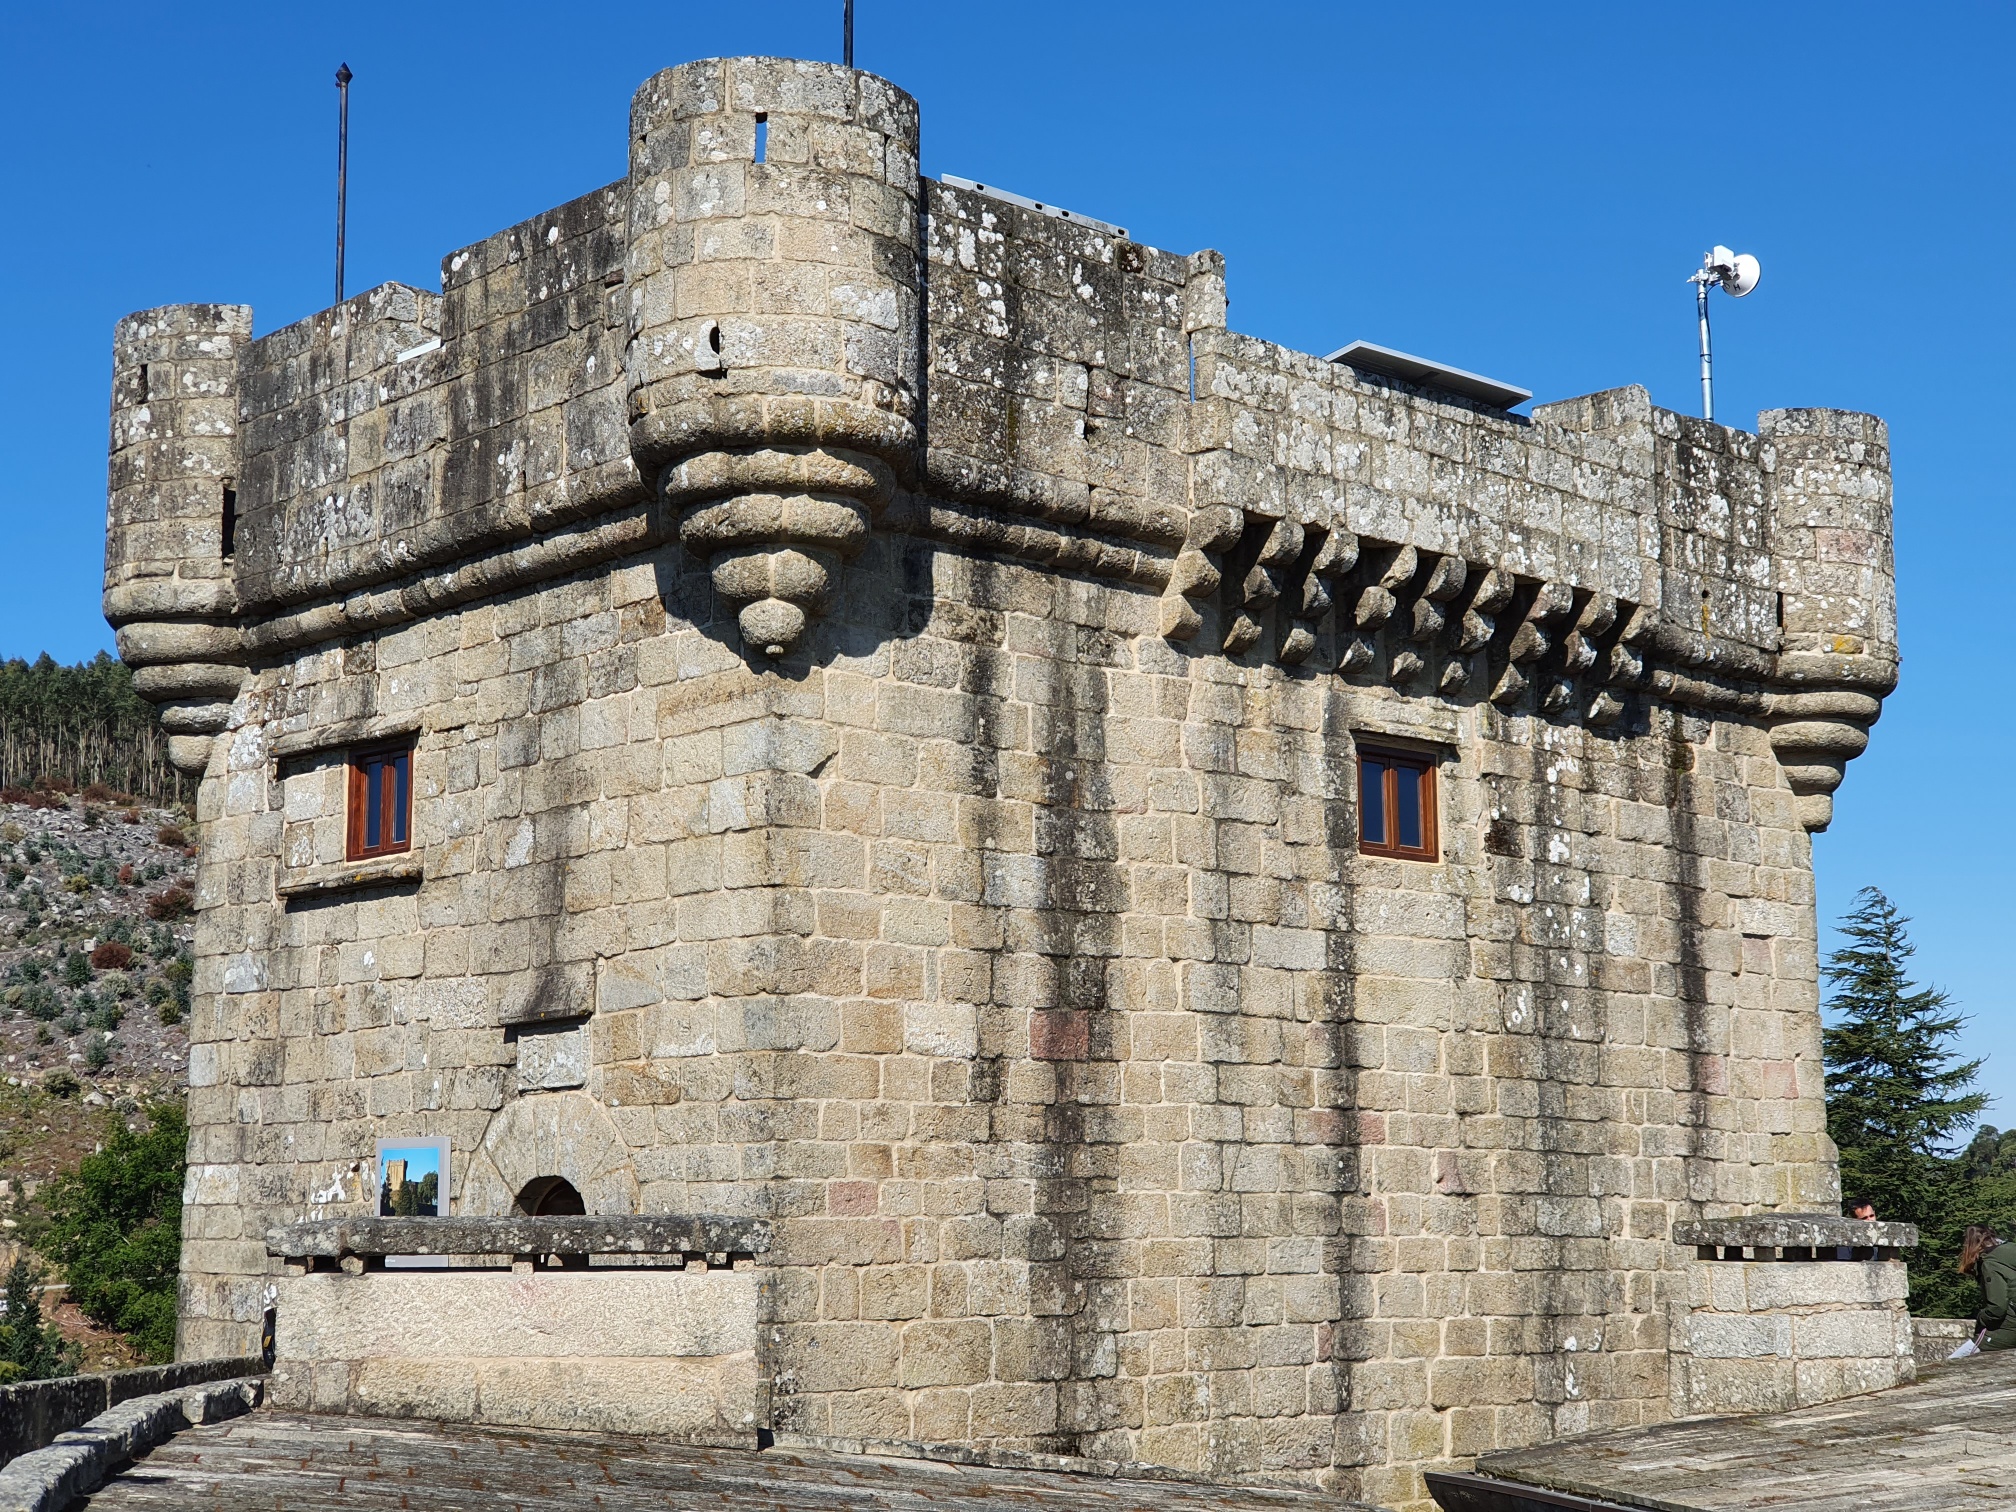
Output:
[0, 0, 2016, 1125]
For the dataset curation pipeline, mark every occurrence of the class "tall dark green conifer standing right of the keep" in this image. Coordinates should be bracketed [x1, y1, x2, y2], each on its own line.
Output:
[1820, 887, 2016, 1316]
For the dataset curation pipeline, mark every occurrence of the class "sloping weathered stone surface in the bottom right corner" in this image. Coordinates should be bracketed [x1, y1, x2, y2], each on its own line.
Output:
[1478, 1355, 2016, 1512]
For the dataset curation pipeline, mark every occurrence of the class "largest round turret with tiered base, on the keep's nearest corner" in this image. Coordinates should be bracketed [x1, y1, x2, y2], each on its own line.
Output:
[625, 58, 919, 657]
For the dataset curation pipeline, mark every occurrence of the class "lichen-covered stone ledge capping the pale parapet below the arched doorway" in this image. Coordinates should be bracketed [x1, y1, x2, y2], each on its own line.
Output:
[266, 1214, 770, 1264]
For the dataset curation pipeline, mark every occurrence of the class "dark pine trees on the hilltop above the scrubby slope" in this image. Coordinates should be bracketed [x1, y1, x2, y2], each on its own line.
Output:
[0, 651, 181, 802]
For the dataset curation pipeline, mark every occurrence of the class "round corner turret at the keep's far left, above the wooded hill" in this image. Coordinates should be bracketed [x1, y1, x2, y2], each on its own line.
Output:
[105, 304, 252, 772]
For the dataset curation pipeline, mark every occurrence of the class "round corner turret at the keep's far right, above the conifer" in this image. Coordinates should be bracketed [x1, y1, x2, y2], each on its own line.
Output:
[1758, 409, 1897, 831]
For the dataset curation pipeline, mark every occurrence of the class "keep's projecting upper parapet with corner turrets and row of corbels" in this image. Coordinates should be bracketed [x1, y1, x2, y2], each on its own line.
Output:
[107, 58, 1897, 827]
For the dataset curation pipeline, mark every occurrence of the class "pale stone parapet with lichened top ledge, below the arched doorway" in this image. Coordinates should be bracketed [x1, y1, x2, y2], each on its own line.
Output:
[266, 1214, 770, 1445]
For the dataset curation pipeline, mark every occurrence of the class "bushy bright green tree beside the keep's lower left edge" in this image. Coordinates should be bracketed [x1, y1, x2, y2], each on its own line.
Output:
[40, 1103, 190, 1361]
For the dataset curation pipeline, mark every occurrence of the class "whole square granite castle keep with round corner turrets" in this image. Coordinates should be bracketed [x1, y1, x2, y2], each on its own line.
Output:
[105, 58, 1901, 1504]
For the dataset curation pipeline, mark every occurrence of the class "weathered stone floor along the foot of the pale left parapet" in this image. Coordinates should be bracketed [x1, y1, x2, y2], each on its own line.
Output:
[75, 1411, 1351, 1512]
